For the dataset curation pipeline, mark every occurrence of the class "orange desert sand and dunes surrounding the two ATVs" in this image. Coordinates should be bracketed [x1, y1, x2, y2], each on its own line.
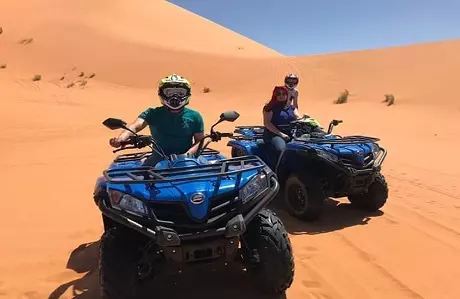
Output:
[0, 0, 460, 299]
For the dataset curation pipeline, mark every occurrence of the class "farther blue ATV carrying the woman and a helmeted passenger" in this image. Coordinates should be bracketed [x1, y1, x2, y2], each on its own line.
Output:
[228, 115, 388, 221]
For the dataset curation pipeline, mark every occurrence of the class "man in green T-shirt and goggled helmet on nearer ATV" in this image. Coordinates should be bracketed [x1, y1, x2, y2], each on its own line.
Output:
[109, 74, 204, 166]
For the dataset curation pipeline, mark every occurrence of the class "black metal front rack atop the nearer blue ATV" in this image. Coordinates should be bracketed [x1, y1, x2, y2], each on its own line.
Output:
[103, 156, 265, 184]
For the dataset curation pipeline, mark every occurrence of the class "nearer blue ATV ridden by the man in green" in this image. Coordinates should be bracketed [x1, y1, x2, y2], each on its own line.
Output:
[94, 111, 294, 299]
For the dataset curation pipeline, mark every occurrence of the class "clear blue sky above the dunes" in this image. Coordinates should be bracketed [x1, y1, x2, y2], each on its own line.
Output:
[169, 0, 460, 55]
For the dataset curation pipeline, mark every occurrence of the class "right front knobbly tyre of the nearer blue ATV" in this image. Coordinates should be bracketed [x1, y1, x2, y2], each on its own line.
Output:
[242, 209, 294, 294]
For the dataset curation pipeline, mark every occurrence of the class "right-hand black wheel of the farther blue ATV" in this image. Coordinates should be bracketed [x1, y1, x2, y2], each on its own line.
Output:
[348, 173, 388, 212]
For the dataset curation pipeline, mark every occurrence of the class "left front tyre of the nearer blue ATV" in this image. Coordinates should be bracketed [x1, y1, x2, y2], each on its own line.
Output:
[99, 227, 145, 299]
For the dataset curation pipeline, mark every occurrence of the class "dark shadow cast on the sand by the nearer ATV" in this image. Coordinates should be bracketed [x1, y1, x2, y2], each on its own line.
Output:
[48, 241, 286, 299]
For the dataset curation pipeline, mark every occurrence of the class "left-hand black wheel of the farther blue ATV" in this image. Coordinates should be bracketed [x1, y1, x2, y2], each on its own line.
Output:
[284, 174, 326, 221]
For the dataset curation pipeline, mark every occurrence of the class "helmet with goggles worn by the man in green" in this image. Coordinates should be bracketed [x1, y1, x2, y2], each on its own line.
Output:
[158, 74, 192, 110]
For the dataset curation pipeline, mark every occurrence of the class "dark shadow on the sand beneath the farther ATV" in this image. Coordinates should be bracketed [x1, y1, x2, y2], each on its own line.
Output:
[269, 197, 383, 235]
